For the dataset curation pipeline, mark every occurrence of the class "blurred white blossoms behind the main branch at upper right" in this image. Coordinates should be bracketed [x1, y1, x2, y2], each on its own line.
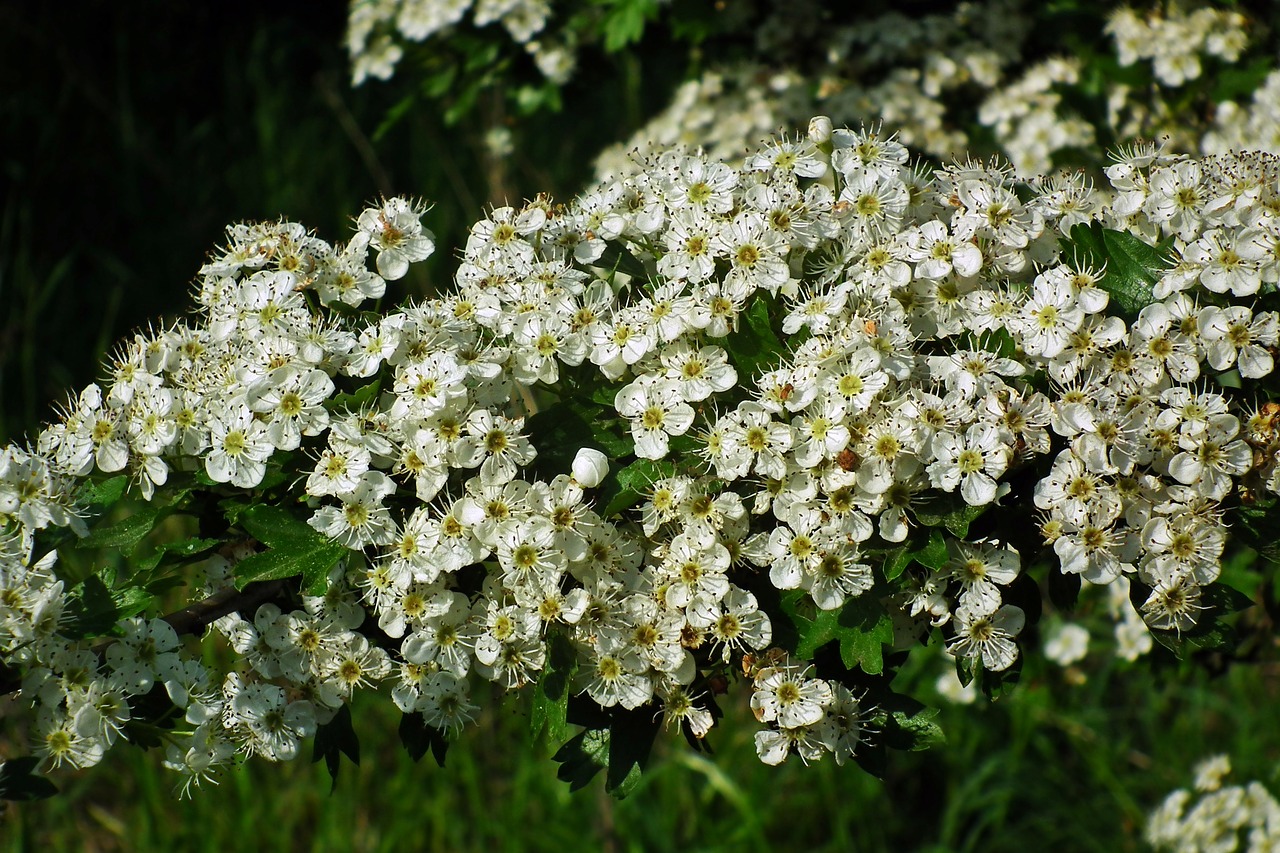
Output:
[596, 0, 1280, 178]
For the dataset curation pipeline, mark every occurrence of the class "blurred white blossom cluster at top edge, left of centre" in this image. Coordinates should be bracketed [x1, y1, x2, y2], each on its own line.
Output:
[346, 0, 577, 86]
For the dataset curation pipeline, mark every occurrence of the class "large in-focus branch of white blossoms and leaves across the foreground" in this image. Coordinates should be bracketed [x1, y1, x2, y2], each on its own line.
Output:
[0, 118, 1280, 795]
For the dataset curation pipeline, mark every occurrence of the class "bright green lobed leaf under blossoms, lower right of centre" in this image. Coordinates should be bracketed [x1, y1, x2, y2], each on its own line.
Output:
[782, 589, 893, 675]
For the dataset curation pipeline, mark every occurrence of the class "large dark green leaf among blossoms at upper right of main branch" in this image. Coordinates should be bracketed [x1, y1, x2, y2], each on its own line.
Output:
[1064, 222, 1170, 318]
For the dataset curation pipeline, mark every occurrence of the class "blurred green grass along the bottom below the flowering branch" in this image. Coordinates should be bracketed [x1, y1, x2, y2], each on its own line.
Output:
[10, 637, 1280, 853]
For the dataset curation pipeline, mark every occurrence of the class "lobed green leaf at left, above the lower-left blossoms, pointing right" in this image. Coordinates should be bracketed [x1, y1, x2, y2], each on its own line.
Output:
[236, 503, 348, 594]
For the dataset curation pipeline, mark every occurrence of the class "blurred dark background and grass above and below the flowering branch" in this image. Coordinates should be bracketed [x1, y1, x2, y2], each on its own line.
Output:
[0, 0, 1280, 852]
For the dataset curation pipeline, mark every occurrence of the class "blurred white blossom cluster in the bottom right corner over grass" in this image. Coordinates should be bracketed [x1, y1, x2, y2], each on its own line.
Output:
[1146, 756, 1280, 853]
